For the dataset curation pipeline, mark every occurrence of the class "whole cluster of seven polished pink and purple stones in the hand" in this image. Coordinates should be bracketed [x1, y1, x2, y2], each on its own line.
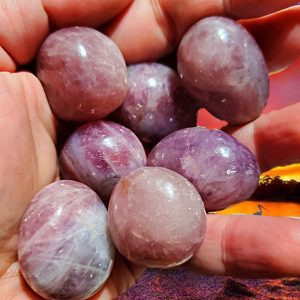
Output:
[18, 17, 269, 299]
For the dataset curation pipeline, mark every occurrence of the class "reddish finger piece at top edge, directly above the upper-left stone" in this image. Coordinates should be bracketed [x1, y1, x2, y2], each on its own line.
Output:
[43, 0, 133, 28]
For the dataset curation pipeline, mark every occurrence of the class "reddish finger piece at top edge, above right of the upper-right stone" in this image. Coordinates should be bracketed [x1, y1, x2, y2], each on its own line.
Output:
[224, 0, 298, 19]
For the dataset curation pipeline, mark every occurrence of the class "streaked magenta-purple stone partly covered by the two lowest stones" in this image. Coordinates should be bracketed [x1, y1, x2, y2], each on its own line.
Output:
[59, 121, 147, 202]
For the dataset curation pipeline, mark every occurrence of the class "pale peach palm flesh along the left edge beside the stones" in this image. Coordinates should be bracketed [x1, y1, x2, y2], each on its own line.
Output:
[0, 73, 57, 299]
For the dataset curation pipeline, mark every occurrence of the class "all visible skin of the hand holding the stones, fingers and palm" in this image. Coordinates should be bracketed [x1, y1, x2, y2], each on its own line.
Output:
[0, 0, 300, 300]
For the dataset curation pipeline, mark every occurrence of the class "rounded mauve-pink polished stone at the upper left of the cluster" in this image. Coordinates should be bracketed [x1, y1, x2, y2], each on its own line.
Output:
[37, 27, 127, 121]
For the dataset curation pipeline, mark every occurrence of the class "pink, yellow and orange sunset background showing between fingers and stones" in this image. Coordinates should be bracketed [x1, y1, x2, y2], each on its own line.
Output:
[198, 58, 300, 217]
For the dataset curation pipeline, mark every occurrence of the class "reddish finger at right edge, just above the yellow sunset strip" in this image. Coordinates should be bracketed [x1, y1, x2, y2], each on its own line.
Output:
[224, 102, 300, 171]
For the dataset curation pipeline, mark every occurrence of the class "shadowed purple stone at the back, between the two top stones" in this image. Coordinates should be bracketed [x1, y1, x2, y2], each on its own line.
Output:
[115, 63, 196, 143]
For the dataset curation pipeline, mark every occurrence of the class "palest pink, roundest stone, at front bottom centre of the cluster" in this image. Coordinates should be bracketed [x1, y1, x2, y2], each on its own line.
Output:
[108, 167, 206, 268]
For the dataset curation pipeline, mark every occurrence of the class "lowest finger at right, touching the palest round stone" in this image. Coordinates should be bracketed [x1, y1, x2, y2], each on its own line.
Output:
[189, 215, 300, 278]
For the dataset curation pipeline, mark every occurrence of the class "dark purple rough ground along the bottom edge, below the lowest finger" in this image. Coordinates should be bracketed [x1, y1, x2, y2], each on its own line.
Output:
[117, 269, 300, 300]
